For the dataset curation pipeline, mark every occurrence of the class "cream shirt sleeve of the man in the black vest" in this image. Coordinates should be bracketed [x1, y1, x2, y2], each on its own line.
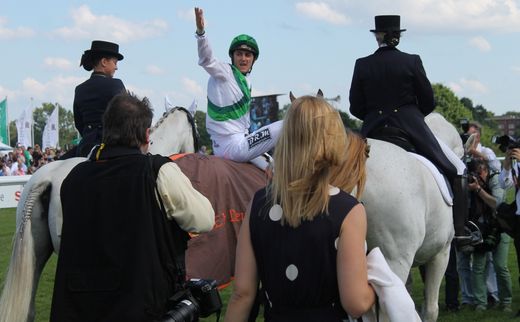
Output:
[157, 162, 215, 232]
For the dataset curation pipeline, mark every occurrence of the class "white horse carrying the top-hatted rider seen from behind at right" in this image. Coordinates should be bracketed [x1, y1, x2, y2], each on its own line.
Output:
[361, 113, 463, 321]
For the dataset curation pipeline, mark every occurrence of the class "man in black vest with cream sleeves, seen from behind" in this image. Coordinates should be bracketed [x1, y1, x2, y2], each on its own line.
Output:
[50, 93, 220, 322]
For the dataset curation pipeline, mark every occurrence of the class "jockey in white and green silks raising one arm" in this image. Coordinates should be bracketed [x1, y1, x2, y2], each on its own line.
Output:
[195, 8, 282, 169]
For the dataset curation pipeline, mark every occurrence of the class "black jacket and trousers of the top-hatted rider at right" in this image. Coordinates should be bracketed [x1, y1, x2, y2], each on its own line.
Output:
[350, 47, 457, 178]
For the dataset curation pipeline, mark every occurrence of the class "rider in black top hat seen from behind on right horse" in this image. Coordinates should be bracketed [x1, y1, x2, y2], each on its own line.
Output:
[350, 15, 479, 248]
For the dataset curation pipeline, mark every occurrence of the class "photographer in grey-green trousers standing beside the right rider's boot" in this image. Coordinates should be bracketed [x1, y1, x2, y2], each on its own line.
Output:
[468, 159, 512, 312]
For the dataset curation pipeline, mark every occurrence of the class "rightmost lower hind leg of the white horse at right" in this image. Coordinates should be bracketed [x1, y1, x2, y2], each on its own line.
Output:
[422, 243, 451, 322]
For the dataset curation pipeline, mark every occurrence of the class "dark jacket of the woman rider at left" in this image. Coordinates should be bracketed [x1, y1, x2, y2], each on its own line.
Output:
[73, 72, 125, 156]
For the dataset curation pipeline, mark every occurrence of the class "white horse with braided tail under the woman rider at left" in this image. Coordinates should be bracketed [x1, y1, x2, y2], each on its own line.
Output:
[0, 107, 197, 322]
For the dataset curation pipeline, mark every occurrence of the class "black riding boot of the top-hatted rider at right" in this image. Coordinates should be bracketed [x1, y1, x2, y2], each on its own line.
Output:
[452, 175, 482, 250]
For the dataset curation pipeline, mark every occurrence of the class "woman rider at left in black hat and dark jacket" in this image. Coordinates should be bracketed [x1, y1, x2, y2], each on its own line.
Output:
[60, 40, 125, 159]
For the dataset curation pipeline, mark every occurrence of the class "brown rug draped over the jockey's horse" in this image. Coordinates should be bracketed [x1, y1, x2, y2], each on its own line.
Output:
[170, 153, 267, 285]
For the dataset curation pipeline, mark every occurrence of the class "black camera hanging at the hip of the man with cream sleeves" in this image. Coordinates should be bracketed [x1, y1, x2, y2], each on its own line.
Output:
[160, 278, 222, 322]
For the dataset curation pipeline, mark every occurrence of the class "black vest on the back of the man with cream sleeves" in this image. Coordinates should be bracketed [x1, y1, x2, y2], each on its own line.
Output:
[50, 148, 187, 322]
